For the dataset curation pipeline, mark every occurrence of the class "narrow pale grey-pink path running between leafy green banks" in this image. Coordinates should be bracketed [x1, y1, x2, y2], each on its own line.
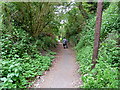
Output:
[33, 43, 82, 88]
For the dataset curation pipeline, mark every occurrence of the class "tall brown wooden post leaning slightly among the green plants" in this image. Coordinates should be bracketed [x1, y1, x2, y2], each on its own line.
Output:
[92, 0, 103, 69]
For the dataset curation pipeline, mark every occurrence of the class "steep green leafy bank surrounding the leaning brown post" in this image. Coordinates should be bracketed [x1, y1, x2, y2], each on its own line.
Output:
[76, 3, 120, 88]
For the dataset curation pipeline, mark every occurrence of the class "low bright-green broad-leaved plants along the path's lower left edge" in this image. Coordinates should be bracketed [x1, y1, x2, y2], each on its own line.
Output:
[1, 54, 51, 88]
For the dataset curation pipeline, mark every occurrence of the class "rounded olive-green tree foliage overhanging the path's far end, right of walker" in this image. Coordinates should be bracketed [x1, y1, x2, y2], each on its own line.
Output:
[65, 7, 84, 45]
